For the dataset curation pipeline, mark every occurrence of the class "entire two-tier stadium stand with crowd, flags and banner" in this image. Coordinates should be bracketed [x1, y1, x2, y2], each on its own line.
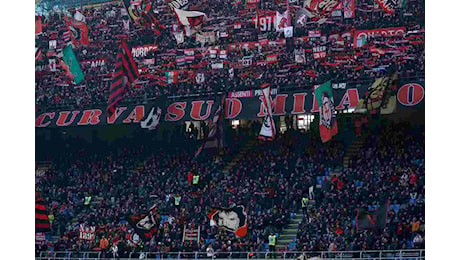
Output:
[35, 0, 425, 259]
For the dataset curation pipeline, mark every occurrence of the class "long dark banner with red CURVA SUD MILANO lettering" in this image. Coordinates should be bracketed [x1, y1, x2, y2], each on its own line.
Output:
[35, 81, 425, 128]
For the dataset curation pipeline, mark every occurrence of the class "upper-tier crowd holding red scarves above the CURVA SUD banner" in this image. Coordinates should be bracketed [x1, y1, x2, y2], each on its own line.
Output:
[36, 0, 425, 110]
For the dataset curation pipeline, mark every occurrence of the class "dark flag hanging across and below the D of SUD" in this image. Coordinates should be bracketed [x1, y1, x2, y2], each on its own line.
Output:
[194, 93, 225, 159]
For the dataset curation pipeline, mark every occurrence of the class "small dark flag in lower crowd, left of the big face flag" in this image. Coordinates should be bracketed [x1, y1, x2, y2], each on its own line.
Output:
[126, 207, 161, 241]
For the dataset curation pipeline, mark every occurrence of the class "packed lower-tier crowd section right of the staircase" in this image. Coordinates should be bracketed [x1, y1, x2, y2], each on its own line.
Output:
[296, 124, 425, 252]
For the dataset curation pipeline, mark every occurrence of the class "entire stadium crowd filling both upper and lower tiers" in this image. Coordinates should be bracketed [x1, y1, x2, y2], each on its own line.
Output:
[35, 0, 425, 257]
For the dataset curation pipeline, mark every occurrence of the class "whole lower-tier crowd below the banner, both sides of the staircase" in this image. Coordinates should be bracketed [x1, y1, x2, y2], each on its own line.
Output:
[37, 120, 425, 256]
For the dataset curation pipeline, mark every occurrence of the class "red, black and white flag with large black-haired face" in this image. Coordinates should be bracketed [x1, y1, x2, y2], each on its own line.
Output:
[208, 205, 248, 237]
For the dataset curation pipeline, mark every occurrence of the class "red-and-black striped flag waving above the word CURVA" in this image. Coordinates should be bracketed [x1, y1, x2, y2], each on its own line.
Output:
[107, 40, 139, 117]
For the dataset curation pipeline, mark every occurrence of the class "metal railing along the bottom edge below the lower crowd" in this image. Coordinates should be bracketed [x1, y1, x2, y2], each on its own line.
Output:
[35, 249, 425, 260]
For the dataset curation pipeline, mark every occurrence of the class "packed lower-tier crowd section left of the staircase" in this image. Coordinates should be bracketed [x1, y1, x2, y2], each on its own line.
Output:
[36, 127, 343, 256]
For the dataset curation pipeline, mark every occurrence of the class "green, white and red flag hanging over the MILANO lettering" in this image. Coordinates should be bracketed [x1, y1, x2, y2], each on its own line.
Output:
[315, 81, 338, 143]
